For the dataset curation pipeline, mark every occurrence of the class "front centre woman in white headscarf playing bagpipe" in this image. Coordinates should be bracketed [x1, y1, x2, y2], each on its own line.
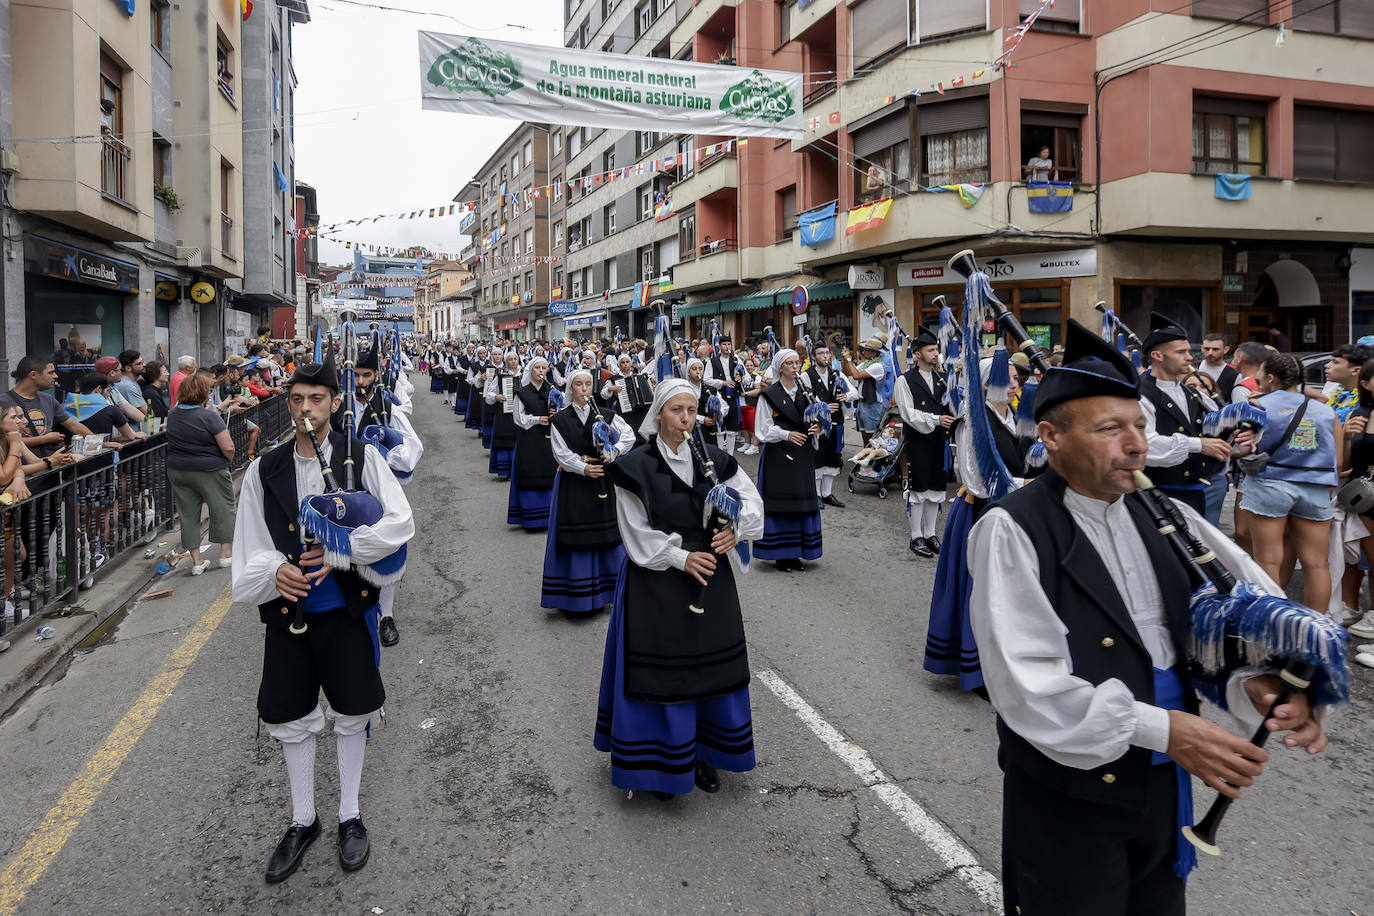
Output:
[594, 379, 764, 801]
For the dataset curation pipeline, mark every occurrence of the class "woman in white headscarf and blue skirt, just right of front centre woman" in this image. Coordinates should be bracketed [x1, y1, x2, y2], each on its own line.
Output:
[754, 350, 820, 571]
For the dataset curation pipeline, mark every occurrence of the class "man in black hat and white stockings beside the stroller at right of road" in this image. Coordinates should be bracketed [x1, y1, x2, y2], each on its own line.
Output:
[893, 328, 954, 559]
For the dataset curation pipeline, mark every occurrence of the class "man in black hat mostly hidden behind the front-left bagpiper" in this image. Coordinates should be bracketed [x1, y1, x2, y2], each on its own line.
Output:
[330, 338, 425, 645]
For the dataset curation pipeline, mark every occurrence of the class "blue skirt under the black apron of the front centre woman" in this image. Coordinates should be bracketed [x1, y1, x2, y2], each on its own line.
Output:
[592, 560, 754, 795]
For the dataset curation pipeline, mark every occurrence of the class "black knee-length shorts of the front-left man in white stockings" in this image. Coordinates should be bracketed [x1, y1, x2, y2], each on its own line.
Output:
[258, 608, 386, 725]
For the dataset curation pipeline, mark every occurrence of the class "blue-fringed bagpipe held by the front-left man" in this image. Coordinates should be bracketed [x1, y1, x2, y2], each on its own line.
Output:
[293, 309, 407, 623]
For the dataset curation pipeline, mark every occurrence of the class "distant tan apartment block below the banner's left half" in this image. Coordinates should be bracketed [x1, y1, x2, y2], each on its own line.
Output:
[453, 122, 563, 339]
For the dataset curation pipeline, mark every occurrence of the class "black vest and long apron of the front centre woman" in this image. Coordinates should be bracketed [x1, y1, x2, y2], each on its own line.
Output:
[607, 441, 749, 703]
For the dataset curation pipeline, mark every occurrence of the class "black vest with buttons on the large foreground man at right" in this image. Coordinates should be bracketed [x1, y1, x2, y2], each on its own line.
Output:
[974, 470, 1198, 806]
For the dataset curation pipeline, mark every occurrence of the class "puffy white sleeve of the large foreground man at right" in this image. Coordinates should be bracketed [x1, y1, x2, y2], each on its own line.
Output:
[969, 508, 1169, 769]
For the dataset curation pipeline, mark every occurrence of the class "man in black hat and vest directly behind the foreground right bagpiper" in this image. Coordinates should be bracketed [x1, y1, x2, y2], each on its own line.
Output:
[1140, 312, 1231, 512]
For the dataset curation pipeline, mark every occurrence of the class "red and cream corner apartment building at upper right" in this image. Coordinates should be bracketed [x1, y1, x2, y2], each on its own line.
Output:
[634, 0, 1374, 350]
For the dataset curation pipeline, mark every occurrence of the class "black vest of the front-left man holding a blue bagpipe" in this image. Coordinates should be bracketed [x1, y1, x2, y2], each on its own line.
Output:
[258, 433, 376, 629]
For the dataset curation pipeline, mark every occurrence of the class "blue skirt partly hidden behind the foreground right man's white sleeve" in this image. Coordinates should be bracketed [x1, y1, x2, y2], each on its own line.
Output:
[921, 499, 982, 691]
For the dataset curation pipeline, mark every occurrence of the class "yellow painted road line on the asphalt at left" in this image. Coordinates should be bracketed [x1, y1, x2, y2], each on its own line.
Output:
[0, 585, 234, 916]
